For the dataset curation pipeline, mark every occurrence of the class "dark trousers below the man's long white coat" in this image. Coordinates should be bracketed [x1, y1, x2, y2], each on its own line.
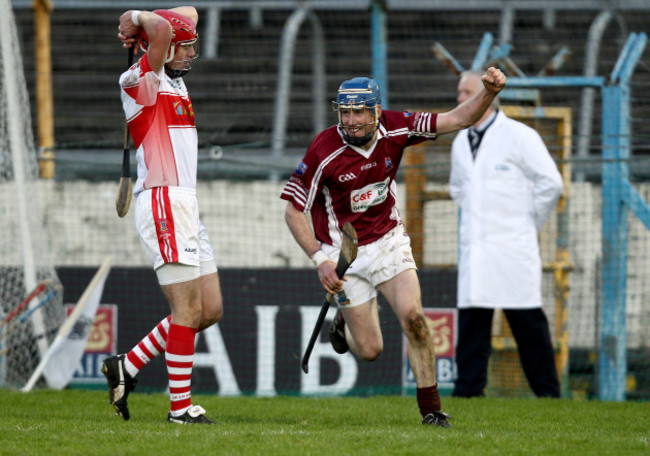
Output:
[453, 308, 560, 397]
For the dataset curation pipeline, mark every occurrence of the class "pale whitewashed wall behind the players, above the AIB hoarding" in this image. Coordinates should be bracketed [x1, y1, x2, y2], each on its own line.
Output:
[5, 181, 650, 347]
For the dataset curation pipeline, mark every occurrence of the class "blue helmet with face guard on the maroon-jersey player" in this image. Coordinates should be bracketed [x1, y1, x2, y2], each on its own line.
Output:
[332, 77, 381, 146]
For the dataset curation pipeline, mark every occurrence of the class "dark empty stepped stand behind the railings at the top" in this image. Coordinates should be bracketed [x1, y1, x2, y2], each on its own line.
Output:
[11, 4, 650, 157]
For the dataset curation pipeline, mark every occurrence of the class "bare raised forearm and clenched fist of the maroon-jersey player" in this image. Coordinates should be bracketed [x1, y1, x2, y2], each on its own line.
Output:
[436, 67, 506, 134]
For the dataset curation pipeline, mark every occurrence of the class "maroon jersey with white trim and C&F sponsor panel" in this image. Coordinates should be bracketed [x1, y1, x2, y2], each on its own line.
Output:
[281, 111, 437, 247]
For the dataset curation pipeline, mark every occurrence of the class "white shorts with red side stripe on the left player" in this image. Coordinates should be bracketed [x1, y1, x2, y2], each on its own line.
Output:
[135, 187, 217, 283]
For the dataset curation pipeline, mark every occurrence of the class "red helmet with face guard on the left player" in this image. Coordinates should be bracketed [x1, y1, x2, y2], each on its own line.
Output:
[140, 9, 199, 78]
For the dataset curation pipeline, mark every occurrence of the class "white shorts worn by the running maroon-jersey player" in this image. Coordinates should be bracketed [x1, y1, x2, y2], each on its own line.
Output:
[321, 224, 417, 307]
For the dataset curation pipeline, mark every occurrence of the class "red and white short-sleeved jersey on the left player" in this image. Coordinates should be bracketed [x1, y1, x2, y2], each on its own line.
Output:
[120, 54, 198, 195]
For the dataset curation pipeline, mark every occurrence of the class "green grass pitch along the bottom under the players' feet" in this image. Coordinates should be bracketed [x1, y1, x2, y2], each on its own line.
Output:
[0, 390, 650, 456]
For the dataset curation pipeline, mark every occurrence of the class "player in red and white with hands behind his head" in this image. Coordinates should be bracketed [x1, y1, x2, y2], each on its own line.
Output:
[102, 6, 223, 424]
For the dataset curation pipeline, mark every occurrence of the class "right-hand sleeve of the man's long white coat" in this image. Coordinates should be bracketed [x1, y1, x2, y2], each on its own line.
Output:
[520, 129, 562, 231]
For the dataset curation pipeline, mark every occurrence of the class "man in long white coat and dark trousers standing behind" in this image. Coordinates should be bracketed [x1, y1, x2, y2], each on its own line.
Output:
[449, 72, 562, 397]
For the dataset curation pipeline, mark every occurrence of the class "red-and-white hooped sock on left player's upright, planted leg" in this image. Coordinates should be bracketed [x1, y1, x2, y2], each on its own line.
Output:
[165, 323, 197, 416]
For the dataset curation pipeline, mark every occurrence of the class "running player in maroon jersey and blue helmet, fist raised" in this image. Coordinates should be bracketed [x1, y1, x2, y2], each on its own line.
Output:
[281, 68, 506, 427]
